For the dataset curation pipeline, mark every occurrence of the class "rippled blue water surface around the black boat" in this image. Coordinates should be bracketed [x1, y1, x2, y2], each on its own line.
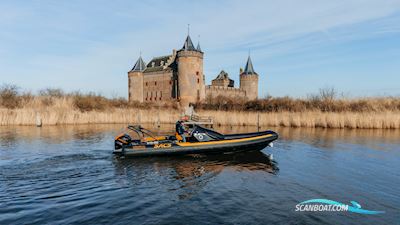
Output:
[0, 125, 400, 224]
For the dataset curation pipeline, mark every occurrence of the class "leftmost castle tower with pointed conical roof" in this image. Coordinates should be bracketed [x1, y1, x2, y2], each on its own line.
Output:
[128, 56, 146, 102]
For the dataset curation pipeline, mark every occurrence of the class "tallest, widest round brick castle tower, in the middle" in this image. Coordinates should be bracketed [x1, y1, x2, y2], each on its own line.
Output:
[177, 35, 206, 106]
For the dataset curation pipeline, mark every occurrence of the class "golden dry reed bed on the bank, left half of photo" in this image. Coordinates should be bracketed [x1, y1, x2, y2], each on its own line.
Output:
[0, 97, 179, 125]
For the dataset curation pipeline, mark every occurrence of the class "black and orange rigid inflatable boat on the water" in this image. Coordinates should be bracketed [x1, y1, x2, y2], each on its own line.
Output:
[114, 125, 278, 156]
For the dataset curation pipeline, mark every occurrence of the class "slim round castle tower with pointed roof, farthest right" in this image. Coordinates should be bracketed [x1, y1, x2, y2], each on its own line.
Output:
[240, 55, 258, 100]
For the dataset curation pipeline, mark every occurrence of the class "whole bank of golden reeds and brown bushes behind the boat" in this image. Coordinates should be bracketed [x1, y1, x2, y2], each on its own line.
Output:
[0, 86, 400, 129]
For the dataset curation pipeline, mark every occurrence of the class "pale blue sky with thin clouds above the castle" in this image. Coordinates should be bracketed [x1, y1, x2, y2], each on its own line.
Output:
[0, 0, 400, 97]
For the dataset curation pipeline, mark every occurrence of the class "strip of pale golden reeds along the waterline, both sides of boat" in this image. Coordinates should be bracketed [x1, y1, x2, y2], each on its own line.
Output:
[0, 107, 400, 129]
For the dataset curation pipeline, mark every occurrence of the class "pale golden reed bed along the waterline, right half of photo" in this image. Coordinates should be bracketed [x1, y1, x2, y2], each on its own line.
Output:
[201, 110, 400, 129]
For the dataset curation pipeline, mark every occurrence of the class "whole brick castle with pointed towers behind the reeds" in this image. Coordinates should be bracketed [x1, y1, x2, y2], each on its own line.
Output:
[128, 35, 258, 106]
